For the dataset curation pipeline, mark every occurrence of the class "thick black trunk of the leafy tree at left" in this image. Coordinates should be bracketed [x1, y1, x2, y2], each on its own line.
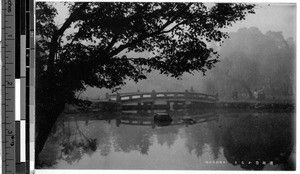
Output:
[35, 3, 88, 164]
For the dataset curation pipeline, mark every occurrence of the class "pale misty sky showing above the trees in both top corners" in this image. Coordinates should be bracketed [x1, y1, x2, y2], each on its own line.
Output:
[52, 3, 296, 39]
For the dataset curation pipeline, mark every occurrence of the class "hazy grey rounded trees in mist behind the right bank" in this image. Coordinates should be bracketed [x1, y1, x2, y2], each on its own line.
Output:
[207, 27, 296, 98]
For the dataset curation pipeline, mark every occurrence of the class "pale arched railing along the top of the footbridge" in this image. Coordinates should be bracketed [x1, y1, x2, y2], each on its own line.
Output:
[106, 91, 218, 102]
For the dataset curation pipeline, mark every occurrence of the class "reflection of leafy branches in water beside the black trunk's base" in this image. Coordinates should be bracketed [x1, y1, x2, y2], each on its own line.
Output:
[37, 116, 98, 168]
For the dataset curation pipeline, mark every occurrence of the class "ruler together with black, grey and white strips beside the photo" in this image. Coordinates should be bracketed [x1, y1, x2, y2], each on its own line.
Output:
[1, 0, 35, 174]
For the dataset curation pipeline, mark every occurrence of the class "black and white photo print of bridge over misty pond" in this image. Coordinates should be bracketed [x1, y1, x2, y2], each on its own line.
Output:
[34, 1, 297, 171]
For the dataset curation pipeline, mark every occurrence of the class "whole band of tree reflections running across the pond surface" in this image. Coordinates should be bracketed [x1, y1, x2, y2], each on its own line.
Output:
[41, 111, 294, 170]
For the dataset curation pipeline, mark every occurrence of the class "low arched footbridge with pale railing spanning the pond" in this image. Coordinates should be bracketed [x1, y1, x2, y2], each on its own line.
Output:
[106, 90, 218, 111]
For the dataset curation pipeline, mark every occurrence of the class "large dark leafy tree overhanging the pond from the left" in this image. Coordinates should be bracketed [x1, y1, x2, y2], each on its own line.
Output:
[36, 2, 254, 162]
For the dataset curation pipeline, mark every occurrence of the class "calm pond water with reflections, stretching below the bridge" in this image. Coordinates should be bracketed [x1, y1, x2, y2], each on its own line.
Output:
[40, 112, 295, 170]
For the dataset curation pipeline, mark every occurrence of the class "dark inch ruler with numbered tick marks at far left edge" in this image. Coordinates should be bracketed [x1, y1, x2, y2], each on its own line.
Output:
[1, 0, 17, 174]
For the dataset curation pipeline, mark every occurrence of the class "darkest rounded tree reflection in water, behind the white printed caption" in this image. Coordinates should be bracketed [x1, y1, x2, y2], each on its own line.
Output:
[223, 114, 294, 170]
